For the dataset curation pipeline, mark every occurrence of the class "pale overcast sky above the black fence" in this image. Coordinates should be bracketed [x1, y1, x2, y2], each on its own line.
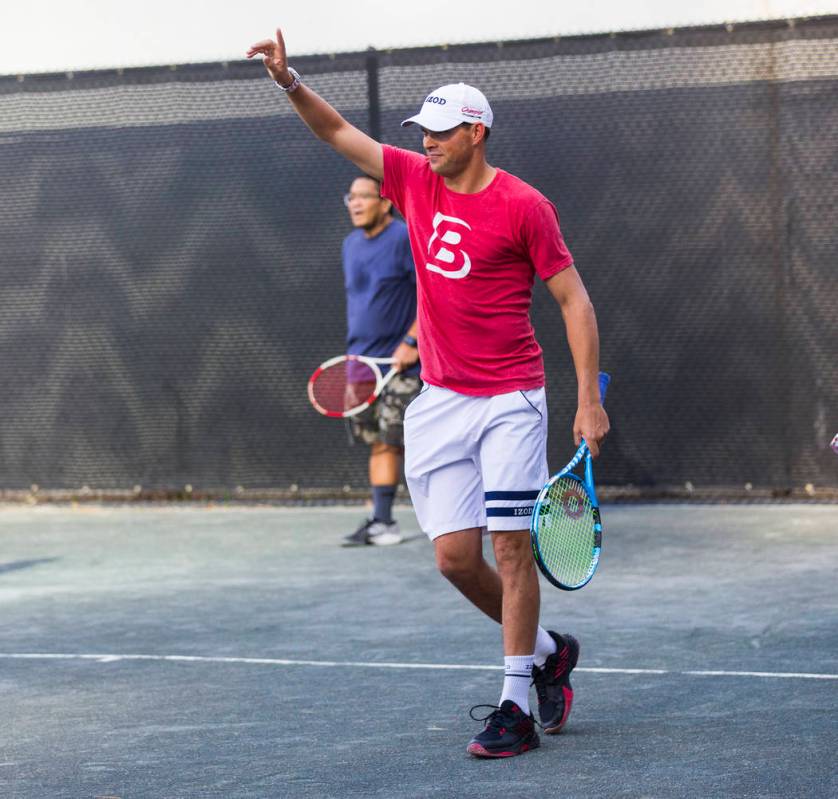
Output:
[0, 0, 838, 74]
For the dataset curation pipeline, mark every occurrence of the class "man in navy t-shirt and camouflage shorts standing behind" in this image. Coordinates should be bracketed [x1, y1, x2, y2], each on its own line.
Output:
[342, 176, 421, 546]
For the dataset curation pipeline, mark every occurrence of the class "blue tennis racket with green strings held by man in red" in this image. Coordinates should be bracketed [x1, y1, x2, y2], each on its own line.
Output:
[530, 372, 611, 591]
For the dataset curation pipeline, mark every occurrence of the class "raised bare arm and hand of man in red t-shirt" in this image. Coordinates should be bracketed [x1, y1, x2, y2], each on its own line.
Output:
[247, 28, 384, 180]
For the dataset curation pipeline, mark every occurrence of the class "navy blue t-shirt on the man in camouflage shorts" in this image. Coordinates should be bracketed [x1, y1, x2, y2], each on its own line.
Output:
[342, 219, 419, 374]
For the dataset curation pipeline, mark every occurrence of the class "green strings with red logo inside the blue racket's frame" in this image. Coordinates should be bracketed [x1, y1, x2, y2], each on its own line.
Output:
[538, 477, 595, 586]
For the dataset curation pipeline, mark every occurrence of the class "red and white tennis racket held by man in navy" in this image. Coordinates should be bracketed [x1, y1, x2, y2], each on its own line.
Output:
[308, 355, 398, 419]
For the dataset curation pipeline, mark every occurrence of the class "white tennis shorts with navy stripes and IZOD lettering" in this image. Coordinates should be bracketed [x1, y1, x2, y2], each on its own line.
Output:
[404, 384, 547, 540]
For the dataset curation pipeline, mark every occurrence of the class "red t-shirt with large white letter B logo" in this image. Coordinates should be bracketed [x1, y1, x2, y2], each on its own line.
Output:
[381, 145, 573, 396]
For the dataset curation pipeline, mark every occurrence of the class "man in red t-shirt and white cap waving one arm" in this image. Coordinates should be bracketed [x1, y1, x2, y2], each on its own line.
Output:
[247, 31, 609, 757]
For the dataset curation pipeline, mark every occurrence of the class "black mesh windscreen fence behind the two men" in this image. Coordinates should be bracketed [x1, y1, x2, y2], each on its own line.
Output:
[0, 17, 838, 490]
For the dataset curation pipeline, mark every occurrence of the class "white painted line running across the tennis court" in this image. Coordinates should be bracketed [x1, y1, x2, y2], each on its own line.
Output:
[0, 652, 838, 680]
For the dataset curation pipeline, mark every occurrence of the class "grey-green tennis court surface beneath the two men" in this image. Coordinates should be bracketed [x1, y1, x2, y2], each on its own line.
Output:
[0, 504, 838, 799]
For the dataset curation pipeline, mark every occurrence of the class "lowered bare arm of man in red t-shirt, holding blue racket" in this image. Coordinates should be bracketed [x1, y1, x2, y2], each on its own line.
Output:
[546, 266, 609, 457]
